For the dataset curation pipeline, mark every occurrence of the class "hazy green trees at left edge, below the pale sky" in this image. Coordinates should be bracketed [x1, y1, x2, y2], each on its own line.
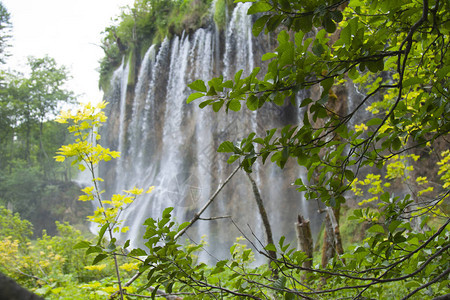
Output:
[0, 57, 88, 235]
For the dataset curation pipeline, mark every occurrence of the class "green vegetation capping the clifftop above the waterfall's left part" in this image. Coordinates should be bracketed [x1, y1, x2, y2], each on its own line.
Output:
[99, 0, 220, 90]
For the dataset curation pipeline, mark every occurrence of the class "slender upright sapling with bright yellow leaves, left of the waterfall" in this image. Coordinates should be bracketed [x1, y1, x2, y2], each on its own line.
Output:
[55, 102, 158, 299]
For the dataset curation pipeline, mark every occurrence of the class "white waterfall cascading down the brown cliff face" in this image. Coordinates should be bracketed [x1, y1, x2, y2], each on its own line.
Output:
[100, 3, 322, 260]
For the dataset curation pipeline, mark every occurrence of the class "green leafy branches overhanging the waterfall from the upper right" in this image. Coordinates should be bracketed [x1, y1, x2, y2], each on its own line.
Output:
[187, 1, 450, 204]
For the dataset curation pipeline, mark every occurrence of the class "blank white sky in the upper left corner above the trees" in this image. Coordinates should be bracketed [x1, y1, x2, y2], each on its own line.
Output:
[0, 0, 134, 102]
